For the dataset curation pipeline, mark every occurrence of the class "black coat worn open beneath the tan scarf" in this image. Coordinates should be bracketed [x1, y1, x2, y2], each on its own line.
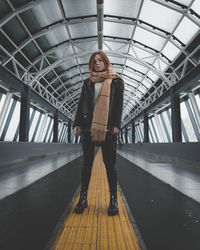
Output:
[74, 78, 124, 130]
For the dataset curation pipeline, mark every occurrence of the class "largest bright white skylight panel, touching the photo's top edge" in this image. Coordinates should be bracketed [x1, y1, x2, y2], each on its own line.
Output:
[139, 0, 182, 32]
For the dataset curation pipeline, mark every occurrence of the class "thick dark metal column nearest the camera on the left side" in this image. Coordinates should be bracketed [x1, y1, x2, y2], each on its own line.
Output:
[19, 86, 31, 141]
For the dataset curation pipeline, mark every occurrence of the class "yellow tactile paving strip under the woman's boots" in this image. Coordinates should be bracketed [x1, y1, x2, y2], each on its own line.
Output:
[52, 150, 141, 250]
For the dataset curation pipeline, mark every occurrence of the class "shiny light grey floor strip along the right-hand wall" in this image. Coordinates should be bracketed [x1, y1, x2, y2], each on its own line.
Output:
[118, 147, 200, 202]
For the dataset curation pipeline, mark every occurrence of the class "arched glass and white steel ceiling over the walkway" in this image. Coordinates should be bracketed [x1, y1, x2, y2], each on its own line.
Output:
[0, 0, 200, 125]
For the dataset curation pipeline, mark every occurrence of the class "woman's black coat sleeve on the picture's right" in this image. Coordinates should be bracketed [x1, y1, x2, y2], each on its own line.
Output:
[113, 78, 124, 129]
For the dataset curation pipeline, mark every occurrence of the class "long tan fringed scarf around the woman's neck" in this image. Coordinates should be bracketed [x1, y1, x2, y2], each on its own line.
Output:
[90, 71, 121, 142]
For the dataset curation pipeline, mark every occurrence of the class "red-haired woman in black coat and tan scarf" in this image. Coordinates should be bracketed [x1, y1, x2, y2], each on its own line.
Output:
[74, 51, 124, 216]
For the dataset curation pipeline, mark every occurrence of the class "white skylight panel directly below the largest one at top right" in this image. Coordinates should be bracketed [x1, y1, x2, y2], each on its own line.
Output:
[134, 27, 166, 50]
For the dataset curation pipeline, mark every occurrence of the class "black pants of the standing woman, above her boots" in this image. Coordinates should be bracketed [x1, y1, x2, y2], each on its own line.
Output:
[81, 131, 117, 192]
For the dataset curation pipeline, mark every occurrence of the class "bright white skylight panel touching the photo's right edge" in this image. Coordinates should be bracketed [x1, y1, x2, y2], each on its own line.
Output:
[174, 17, 199, 44]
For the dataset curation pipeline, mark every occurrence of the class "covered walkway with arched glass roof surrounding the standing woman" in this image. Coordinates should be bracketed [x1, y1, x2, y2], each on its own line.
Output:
[0, 0, 200, 250]
